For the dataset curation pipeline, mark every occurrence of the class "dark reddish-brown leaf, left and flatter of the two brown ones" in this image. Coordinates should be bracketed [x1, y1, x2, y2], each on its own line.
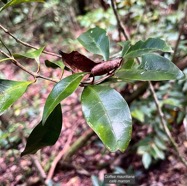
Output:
[59, 51, 99, 73]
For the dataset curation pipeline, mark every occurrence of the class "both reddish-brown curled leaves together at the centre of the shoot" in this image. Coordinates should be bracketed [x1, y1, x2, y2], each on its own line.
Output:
[59, 51, 123, 76]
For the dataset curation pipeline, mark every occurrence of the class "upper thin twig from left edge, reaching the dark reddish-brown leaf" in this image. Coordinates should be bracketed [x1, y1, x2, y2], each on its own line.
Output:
[0, 25, 61, 57]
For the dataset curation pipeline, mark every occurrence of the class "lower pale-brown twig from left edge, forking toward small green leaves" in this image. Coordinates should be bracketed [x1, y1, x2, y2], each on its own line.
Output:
[0, 49, 58, 83]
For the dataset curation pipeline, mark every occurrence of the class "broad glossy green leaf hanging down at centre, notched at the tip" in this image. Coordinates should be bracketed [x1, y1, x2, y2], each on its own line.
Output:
[81, 85, 132, 152]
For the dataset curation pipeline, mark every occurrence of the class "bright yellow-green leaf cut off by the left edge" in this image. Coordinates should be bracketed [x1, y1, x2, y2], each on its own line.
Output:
[0, 79, 31, 115]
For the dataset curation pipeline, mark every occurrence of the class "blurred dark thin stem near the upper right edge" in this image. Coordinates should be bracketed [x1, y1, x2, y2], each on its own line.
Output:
[172, 5, 187, 62]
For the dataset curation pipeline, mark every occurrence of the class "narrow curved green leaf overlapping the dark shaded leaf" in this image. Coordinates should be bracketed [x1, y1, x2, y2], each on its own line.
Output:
[42, 73, 85, 124]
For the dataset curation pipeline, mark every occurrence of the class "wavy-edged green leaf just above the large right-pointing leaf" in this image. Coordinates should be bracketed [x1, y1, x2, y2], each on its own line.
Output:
[124, 38, 172, 59]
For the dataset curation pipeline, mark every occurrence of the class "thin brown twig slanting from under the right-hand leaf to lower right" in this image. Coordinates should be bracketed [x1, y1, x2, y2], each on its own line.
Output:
[149, 81, 187, 167]
